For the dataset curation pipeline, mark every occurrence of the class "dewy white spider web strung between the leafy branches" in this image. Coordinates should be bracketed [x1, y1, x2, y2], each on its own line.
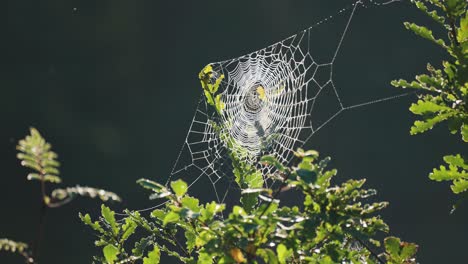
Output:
[166, 1, 408, 203]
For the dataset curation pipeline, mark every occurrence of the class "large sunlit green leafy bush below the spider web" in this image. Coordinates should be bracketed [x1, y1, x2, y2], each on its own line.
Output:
[80, 150, 417, 264]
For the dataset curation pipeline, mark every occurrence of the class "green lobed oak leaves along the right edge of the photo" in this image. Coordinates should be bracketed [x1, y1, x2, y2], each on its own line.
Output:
[392, 0, 468, 198]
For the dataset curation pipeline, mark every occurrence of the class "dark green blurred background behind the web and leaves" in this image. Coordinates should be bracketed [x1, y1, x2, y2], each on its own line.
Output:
[0, 0, 468, 264]
